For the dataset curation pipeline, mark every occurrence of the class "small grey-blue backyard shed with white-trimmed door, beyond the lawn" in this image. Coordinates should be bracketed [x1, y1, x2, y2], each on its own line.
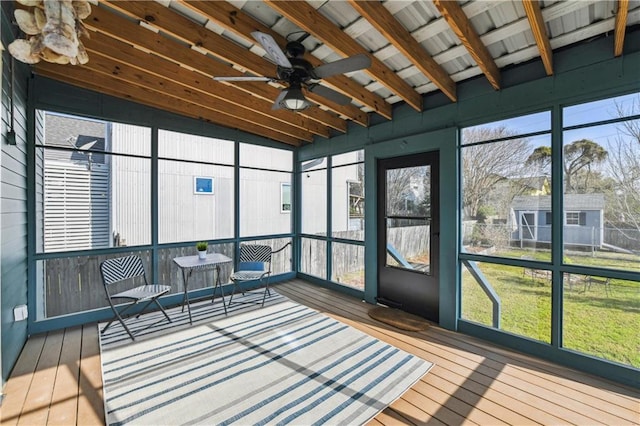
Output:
[510, 194, 604, 248]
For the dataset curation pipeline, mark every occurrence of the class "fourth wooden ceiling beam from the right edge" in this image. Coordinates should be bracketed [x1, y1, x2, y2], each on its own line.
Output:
[349, 0, 456, 102]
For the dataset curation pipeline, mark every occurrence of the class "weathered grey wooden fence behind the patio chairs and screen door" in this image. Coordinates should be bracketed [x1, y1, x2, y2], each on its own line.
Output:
[38, 226, 436, 318]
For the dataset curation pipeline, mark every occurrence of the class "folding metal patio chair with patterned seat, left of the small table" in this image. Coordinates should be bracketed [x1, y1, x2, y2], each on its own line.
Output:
[100, 255, 171, 340]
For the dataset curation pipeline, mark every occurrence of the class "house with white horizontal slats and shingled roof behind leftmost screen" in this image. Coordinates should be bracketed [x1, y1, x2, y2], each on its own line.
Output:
[36, 113, 111, 252]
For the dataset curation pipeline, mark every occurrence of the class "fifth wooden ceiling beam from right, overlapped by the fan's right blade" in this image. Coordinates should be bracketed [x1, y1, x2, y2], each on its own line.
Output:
[264, 0, 422, 111]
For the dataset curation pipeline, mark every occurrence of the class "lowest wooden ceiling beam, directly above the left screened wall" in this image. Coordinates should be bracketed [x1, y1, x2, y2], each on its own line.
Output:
[35, 62, 300, 146]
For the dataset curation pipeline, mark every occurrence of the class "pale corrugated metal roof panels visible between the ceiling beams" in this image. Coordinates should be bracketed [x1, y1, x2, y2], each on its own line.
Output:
[115, 0, 640, 129]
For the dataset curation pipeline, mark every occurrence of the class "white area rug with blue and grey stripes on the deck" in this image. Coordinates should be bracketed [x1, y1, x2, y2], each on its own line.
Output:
[100, 291, 432, 425]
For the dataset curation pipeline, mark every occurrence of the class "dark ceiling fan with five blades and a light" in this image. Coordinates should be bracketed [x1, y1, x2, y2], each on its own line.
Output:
[213, 31, 371, 111]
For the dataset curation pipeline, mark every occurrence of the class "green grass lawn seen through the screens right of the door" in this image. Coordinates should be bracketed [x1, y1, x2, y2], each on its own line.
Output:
[462, 251, 640, 367]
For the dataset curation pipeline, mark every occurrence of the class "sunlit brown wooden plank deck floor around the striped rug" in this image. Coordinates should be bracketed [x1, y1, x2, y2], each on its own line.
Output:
[0, 280, 640, 425]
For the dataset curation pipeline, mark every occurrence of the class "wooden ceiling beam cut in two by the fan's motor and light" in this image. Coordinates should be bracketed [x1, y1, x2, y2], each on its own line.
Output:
[101, 0, 369, 127]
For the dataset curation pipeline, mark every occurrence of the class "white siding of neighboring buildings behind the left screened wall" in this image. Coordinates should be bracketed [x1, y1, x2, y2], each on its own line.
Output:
[42, 119, 296, 252]
